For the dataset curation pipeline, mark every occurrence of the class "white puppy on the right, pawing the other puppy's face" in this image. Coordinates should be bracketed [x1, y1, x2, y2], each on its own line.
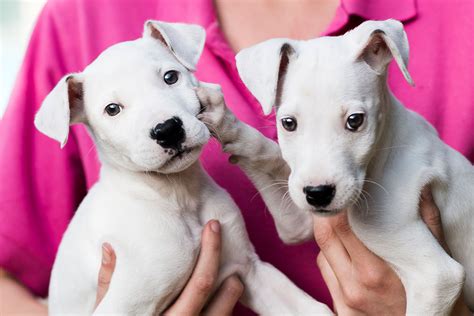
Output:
[199, 20, 474, 315]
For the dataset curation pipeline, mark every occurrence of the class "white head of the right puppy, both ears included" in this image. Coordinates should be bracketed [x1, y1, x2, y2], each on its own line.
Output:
[237, 20, 412, 214]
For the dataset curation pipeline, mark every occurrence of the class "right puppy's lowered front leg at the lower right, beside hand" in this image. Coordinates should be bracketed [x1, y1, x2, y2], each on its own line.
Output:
[352, 219, 465, 315]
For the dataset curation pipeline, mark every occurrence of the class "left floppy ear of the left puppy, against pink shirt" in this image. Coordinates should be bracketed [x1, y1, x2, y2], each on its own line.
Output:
[35, 74, 85, 148]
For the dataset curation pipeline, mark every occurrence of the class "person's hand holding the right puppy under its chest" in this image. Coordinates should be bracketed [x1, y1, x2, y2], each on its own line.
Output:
[314, 187, 470, 315]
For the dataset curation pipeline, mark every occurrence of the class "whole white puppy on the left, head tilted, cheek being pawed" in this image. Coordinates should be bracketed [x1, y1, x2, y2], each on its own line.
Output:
[35, 21, 331, 315]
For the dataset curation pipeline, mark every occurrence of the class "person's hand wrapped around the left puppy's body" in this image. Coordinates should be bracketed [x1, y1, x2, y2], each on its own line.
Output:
[96, 220, 244, 316]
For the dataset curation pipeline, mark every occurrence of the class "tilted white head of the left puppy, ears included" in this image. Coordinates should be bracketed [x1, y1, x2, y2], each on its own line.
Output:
[35, 21, 209, 173]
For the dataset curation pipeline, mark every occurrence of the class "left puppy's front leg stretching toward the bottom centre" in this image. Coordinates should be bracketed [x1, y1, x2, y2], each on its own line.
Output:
[200, 184, 332, 315]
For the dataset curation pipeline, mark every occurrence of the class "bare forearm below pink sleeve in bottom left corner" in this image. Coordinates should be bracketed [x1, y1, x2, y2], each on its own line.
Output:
[0, 269, 48, 315]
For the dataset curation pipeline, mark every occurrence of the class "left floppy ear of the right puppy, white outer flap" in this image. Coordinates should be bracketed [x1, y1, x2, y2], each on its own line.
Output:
[236, 38, 296, 115]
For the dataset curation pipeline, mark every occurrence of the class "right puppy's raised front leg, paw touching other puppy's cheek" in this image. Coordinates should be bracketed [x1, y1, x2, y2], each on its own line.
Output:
[197, 84, 313, 243]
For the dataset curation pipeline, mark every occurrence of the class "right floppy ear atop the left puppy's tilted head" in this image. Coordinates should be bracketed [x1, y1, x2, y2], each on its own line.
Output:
[143, 20, 206, 71]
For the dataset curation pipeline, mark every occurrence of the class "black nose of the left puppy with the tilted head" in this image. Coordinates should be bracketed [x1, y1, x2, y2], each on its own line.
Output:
[150, 116, 186, 149]
